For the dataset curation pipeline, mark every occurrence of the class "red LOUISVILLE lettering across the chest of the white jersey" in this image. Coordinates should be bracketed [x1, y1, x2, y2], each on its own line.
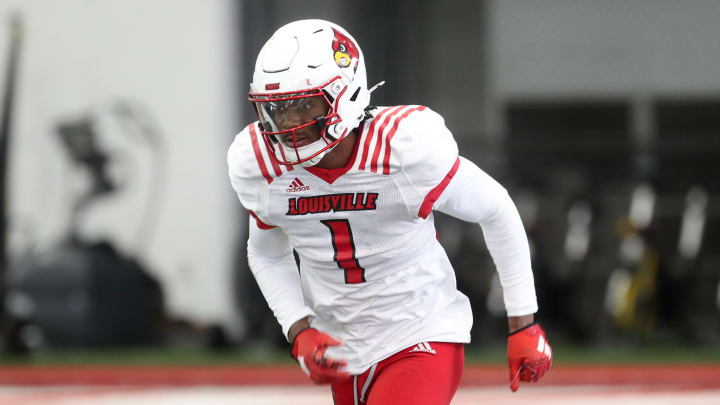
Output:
[285, 193, 378, 215]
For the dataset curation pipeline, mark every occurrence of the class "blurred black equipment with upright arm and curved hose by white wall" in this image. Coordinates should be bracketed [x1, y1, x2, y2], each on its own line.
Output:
[7, 103, 164, 349]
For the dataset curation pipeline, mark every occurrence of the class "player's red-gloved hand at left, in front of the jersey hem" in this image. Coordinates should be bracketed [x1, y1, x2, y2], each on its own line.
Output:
[291, 328, 350, 384]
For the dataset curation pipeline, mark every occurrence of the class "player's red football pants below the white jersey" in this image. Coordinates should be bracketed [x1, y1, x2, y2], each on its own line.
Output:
[331, 342, 465, 405]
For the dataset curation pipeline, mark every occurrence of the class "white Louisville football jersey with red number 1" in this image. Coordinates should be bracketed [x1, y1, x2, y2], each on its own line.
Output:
[228, 106, 472, 374]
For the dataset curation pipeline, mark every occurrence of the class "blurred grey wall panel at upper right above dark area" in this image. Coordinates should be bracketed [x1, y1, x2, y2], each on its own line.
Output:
[482, 0, 720, 136]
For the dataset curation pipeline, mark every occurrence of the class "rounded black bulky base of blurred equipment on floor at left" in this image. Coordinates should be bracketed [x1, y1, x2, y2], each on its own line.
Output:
[8, 239, 163, 348]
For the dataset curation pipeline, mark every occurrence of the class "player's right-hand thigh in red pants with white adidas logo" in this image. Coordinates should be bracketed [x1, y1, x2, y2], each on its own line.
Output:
[367, 343, 464, 405]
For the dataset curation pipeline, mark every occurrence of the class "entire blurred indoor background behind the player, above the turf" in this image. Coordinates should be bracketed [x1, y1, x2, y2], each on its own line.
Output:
[0, 0, 720, 360]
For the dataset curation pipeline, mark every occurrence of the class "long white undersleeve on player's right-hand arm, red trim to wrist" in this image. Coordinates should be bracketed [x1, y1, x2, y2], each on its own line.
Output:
[435, 157, 538, 316]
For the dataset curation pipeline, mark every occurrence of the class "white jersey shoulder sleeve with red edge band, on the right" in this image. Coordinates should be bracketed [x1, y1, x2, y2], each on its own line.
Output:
[392, 107, 459, 218]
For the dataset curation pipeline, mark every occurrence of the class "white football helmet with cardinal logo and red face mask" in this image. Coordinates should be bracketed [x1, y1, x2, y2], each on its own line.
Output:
[248, 20, 370, 167]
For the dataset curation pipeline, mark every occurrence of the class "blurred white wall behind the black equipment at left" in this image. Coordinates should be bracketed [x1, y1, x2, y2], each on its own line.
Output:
[0, 0, 244, 333]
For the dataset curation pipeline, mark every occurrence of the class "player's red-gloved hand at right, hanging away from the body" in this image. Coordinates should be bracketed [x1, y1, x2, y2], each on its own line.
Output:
[508, 323, 552, 392]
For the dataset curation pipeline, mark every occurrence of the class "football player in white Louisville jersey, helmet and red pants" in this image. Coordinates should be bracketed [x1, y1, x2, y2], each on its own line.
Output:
[228, 20, 552, 405]
